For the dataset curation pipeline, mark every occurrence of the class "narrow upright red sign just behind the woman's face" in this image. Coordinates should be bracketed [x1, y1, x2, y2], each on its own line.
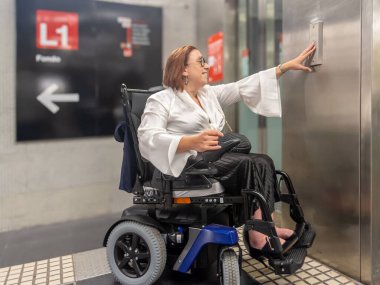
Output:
[208, 32, 223, 82]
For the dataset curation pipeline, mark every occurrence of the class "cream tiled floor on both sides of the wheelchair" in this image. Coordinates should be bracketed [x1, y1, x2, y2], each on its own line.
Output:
[0, 233, 360, 285]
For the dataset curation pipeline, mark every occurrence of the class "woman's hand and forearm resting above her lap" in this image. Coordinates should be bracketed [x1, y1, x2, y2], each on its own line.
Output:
[177, 130, 223, 152]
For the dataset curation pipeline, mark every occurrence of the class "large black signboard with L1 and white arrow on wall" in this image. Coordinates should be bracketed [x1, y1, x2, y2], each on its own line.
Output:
[17, 0, 162, 141]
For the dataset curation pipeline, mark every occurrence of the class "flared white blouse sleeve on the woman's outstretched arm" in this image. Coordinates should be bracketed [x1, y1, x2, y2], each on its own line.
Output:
[208, 68, 282, 117]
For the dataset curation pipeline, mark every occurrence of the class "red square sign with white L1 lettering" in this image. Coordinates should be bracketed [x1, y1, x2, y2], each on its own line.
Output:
[36, 10, 79, 50]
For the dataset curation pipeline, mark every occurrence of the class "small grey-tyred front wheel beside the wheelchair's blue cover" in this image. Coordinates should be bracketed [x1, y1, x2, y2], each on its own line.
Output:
[219, 249, 240, 285]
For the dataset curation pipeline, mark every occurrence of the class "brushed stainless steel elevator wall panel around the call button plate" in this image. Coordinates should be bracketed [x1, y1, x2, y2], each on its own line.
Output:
[282, 0, 361, 279]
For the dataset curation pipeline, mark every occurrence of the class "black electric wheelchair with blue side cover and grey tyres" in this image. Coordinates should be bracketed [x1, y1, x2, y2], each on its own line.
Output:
[103, 84, 315, 285]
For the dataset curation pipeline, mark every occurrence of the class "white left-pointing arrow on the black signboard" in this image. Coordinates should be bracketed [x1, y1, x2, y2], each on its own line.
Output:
[37, 83, 79, 114]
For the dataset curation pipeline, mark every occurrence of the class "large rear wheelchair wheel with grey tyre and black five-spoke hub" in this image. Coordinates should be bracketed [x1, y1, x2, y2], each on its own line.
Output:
[107, 221, 166, 285]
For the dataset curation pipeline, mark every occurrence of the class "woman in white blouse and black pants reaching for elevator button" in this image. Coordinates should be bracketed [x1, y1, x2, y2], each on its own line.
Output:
[138, 44, 315, 252]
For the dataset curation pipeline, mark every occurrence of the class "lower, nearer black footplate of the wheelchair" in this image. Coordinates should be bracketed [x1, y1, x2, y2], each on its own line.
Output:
[269, 248, 307, 275]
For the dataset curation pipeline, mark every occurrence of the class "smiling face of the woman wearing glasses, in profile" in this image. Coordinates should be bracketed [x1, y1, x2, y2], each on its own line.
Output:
[183, 49, 209, 88]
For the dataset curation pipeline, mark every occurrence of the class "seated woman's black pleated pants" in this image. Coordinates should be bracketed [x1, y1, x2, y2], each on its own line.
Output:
[214, 152, 277, 217]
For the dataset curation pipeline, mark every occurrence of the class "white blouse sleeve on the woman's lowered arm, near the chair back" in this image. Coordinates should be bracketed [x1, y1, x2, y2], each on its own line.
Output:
[138, 94, 197, 177]
